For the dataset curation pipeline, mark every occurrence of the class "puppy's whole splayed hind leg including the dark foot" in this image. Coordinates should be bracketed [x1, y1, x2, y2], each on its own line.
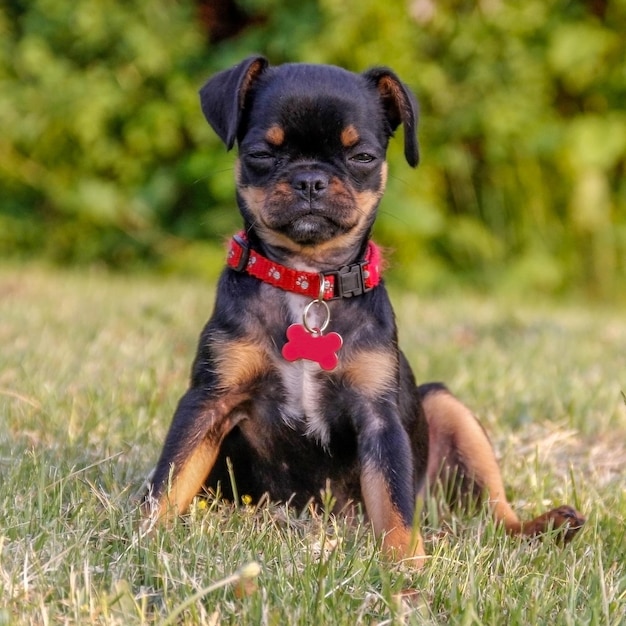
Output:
[418, 383, 585, 541]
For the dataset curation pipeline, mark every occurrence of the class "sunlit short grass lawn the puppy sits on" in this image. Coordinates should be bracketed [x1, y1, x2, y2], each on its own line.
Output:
[0, 268, 626, 626]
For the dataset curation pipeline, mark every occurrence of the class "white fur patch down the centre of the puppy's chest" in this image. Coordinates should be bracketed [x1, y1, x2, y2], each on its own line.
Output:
[279, 294, 329, 446]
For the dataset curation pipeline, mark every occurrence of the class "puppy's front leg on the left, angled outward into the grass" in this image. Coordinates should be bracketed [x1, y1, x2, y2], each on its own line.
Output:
[144, 387, 244, 526]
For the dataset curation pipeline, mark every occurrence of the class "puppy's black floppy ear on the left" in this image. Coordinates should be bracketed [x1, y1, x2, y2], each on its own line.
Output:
[200, 56, 269, 150]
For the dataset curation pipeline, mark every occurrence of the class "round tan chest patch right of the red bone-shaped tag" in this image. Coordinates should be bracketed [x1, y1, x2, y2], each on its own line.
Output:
[344, 350, 397, 398]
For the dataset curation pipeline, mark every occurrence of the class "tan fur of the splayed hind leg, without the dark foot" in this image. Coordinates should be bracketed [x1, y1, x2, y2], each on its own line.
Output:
[423, 391, 521, 534]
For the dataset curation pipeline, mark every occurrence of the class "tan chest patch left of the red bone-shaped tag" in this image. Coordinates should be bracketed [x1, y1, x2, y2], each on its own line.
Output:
[215, 339, 269, 389]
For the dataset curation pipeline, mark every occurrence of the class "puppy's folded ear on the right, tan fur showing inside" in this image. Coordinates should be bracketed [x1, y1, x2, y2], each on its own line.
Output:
[363, 67, 419, 167]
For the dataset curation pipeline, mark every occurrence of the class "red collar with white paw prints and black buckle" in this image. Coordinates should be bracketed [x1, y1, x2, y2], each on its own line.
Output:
[227, 231, 381, 300]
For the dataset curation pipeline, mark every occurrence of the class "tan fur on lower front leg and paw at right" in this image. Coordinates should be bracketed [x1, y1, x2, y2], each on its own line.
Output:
[361, 468, 426, 568]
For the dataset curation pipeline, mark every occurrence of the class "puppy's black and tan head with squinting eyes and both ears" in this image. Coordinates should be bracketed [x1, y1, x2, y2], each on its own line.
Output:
[200, 57, 418, 261]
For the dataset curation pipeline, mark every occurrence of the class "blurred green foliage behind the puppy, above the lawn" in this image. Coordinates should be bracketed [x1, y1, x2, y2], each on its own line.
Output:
[0, 0, 626, 297]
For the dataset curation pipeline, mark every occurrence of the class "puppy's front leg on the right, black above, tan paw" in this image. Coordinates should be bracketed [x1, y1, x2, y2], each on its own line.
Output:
[358, 409, 425, 567]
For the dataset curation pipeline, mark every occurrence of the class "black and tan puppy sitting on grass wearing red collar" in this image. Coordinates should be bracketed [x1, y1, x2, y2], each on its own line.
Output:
[144, 57, 584, 564]
